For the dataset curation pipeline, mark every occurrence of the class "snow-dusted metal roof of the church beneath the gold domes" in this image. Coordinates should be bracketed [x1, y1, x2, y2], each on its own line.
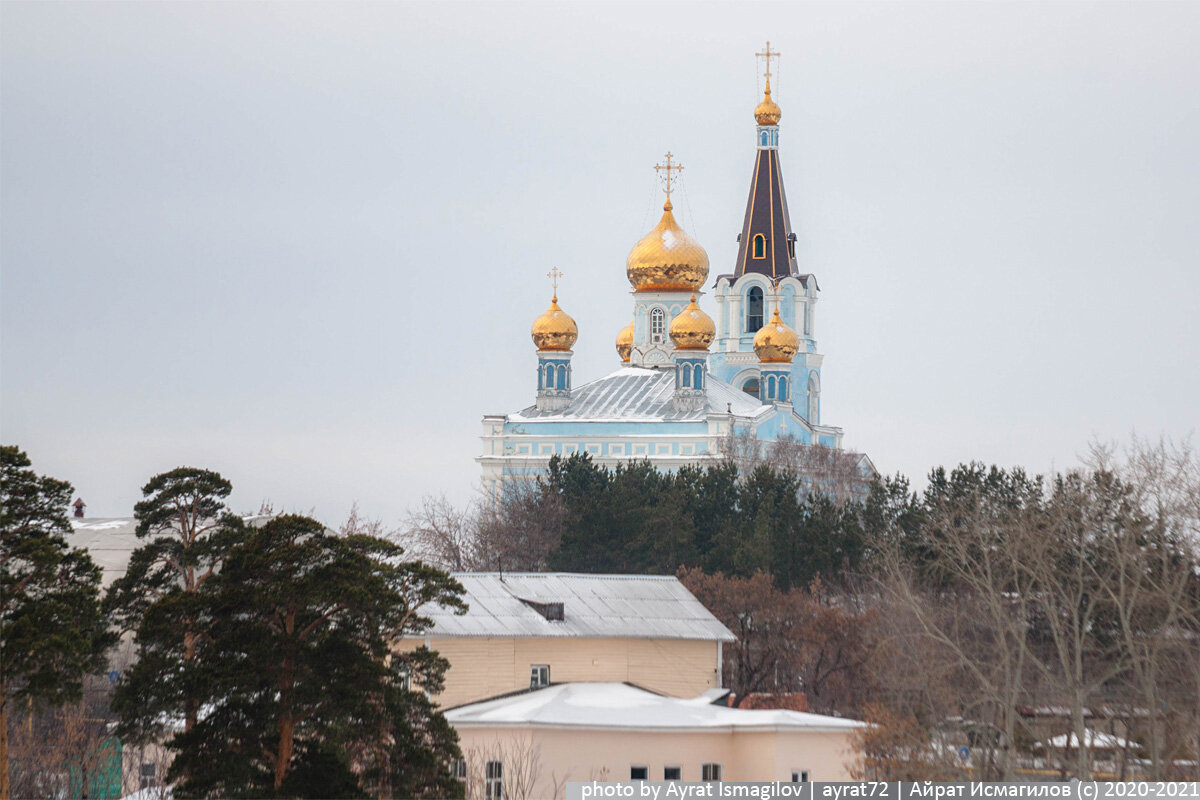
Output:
[509, 367, 772, 422]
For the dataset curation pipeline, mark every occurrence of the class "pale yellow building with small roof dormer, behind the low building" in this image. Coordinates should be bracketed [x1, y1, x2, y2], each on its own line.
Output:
[401, 572, 734, 708]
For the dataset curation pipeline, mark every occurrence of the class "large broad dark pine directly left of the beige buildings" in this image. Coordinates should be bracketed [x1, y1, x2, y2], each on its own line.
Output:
[170, 516, 464, 798]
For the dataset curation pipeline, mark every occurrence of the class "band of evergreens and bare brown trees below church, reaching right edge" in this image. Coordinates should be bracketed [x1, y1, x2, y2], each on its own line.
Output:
[403, 439, 1200, 780]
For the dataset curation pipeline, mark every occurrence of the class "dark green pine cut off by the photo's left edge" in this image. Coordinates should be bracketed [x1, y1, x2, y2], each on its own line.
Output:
[0, 445, 112, 800]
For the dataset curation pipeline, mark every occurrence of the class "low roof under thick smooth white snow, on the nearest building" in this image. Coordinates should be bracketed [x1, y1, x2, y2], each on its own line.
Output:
[445, 682, 865, 733]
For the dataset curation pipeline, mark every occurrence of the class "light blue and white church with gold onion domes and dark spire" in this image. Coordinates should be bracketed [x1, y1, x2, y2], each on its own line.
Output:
[478, 42, 874, 492]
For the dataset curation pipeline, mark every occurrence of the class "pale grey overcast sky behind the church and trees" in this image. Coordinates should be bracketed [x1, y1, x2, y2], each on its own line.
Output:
[0, 1, 1200, 523]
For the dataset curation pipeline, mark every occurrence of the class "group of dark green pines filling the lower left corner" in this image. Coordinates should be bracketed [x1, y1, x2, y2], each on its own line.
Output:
[0, 446, 466, 800]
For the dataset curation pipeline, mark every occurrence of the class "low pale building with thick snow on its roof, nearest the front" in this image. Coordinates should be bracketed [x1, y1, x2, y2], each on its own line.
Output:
[445, 682, 864, 800]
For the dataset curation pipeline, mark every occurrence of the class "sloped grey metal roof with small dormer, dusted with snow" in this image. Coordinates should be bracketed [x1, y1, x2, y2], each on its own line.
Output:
[422, 572, 734, 642]
